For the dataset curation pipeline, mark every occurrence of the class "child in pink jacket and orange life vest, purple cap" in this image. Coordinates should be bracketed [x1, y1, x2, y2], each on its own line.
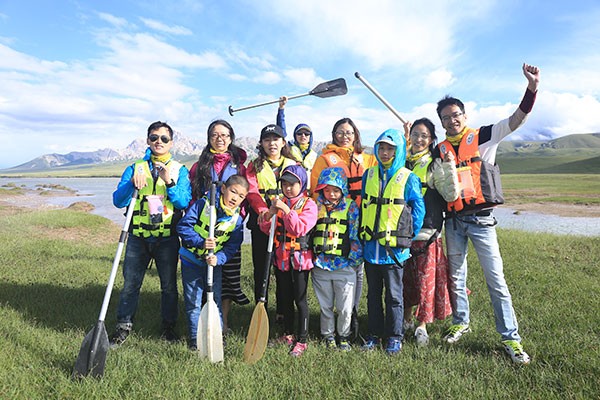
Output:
[260, 165, 317, 357]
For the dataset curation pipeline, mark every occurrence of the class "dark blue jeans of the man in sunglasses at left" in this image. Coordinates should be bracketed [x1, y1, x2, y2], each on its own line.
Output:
[117, 234, 179, 329]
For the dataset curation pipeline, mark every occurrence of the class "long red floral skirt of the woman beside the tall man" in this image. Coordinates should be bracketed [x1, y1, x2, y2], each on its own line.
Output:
[403, 237, 452, 323]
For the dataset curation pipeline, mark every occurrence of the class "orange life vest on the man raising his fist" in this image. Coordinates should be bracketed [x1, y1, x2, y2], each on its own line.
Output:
[438, 128, 504, 212]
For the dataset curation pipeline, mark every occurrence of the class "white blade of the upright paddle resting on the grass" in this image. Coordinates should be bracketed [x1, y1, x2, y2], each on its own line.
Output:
[196, 299, 224, 363]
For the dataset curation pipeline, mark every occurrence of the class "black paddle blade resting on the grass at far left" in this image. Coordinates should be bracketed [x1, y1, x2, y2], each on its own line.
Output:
[72, 321, 109, 379]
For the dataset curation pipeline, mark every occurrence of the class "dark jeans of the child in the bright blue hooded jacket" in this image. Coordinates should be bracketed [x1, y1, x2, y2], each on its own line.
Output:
[365, 262, 404, 340]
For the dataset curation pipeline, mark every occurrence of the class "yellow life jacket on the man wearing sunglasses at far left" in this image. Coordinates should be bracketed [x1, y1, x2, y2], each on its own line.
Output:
[131, 160, 182, 238]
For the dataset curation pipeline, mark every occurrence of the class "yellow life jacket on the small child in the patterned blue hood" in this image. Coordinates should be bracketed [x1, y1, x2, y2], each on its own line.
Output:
[312, 198, 352, 257]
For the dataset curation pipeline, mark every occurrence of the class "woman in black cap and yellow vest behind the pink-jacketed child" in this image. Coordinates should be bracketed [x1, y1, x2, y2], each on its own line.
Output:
[246, 124, 297, 302]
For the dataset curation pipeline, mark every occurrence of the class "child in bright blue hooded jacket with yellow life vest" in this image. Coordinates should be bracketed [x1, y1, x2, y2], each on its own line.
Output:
[359, 129, 425, 355]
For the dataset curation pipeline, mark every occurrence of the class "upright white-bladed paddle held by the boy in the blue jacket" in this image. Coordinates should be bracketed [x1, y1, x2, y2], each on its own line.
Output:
[196, 183, 223, 363]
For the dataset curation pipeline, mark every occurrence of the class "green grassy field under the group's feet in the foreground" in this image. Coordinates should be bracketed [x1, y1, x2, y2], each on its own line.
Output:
[0, 208, 600, 399]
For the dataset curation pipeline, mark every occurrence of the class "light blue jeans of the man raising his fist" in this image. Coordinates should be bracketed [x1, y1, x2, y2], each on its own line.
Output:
[446, 214, 521, 341]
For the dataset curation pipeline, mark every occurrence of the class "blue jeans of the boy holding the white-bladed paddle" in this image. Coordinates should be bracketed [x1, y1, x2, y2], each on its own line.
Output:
[181, 258, 223, 342]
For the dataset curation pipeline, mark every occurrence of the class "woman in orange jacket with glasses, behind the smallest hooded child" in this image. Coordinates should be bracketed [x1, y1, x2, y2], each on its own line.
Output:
[310, 118, 378, 339]
